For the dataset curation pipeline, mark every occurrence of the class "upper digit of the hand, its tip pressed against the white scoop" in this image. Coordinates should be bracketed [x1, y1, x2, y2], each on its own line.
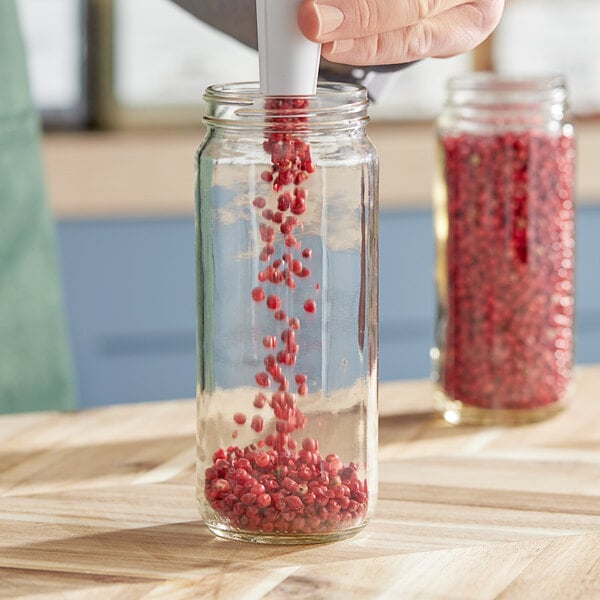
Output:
[298, 0, 465, 43]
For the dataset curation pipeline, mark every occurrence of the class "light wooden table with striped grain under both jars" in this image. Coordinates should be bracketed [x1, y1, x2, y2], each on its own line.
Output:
[0, 367, 600, 600]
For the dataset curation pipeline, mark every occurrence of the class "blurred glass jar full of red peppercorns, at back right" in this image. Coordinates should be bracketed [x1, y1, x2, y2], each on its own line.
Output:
[432, 73, 575, 424]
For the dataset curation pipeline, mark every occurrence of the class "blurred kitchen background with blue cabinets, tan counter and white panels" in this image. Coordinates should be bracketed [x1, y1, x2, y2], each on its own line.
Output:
[17, 0, 600, 407]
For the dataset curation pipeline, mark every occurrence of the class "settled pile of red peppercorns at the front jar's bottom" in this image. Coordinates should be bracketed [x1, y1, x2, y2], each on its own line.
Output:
[205, 438, 367, 534]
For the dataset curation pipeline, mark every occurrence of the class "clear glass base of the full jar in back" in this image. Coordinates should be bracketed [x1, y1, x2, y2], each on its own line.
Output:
[433, 389, 566, 425]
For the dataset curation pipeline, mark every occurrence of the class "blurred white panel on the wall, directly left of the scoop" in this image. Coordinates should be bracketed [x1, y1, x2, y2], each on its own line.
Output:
[114, 0, 258, 107]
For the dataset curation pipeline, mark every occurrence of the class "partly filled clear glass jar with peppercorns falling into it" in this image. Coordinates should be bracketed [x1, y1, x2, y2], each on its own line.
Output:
[196, 83, 378, 544]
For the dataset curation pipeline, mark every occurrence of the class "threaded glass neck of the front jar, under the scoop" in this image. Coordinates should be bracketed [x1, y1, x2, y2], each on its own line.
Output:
[203, 82, 369, 134]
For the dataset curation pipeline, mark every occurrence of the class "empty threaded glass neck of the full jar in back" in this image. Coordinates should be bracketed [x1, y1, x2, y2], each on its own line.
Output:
[442, 73, 568, 128]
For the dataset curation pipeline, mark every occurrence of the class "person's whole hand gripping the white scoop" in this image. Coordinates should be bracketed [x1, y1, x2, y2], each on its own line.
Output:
[298, 0, 504, 66]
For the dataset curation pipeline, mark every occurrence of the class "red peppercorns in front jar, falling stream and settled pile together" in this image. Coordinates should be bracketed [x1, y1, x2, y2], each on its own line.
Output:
[205, 98, 368, 534]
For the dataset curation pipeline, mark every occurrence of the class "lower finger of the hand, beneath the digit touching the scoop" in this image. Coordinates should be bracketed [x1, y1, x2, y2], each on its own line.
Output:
[322, 2, 502, 66]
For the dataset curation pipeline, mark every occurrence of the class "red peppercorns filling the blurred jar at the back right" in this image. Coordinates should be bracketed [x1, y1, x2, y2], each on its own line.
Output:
[438, 132, 574, 409]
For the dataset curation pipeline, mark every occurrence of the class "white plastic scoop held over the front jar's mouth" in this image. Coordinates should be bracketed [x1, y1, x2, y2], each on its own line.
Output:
[256, 0, 321, 96]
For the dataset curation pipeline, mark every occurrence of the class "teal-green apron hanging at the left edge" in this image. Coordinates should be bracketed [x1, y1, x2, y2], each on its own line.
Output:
[0, 0, 74, 413]
